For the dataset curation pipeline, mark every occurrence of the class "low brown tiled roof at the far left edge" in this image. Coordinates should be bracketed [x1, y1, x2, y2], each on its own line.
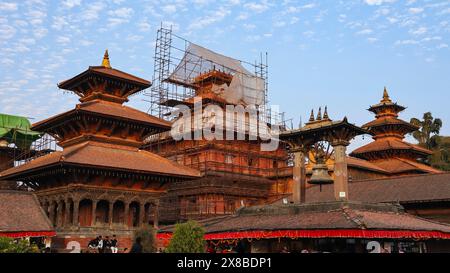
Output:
[0, 190, 53, 233]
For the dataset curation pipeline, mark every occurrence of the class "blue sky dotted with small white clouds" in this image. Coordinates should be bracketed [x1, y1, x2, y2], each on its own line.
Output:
[0, 0, 450, 149]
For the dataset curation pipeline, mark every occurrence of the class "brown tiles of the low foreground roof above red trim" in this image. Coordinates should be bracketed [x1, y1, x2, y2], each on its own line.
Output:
[162, 202, 450, 233]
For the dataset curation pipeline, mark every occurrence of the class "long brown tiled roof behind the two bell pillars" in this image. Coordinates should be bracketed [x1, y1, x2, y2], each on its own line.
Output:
[306, 173, 450, 203]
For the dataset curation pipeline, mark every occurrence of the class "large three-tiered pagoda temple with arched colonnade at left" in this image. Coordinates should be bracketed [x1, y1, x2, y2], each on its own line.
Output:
[0, 51, 199, 248]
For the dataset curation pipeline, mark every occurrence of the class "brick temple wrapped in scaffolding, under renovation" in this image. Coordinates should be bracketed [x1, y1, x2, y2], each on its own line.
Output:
[145, 69, 292, 223]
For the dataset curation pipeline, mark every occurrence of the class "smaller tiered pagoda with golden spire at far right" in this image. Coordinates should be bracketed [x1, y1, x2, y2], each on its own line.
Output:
[350, 88, 440, 176]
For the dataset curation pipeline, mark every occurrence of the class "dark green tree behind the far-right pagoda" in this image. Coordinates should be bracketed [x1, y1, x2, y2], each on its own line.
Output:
[410, 112, 442, 149]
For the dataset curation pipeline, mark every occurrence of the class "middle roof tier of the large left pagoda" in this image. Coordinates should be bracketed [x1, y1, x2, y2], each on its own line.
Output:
[32, 100, 171, 130]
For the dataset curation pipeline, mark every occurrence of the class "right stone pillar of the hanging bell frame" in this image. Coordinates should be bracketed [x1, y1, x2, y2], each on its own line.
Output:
[332, 141, 349, 201]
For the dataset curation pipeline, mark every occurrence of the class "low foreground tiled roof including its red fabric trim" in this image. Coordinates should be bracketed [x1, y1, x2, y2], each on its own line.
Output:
[160, 201, 450, 240]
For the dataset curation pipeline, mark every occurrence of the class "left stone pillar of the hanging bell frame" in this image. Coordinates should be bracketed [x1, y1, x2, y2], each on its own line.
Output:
[292, 149, 306, 204]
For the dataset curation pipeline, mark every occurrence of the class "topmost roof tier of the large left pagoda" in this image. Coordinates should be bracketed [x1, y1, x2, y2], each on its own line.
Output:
[58, 66, 151, 92]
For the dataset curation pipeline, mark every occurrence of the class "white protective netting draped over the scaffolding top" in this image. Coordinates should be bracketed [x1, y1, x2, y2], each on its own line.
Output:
[169, 43, 265, 105]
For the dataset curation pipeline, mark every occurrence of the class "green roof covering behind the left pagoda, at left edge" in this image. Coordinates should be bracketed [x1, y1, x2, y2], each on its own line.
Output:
[0, 114, 42, 149]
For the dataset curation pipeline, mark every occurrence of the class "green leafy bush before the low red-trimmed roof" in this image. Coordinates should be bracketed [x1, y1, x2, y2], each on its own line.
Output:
[167, 221, 206, 253]
